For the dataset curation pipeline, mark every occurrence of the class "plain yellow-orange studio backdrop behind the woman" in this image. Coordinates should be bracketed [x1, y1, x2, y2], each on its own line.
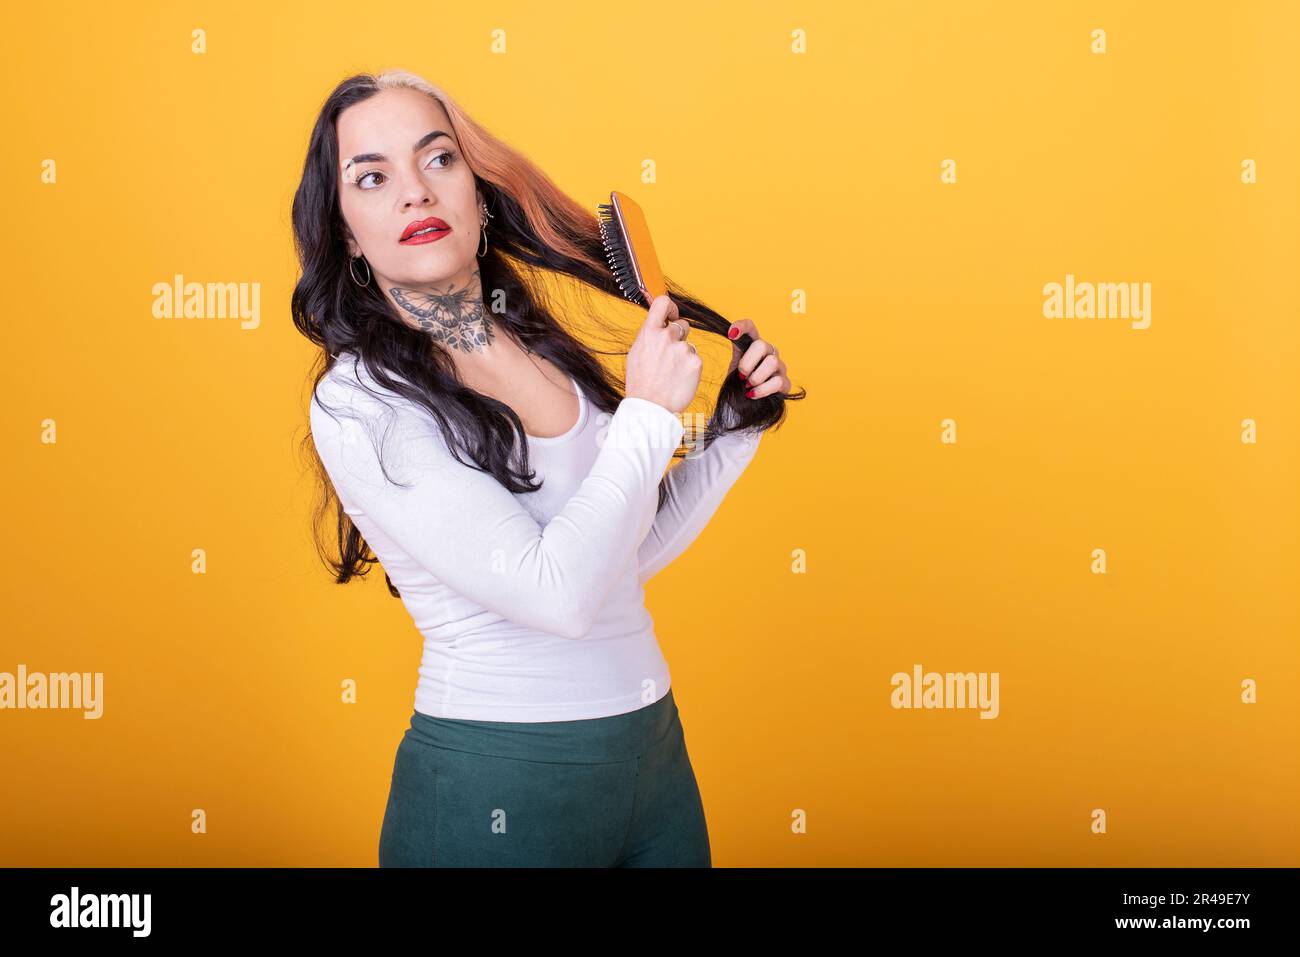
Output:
[0, 1, 1300, 866]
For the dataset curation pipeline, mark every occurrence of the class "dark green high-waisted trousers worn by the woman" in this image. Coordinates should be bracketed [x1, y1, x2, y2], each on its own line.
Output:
[380, 689, 712, 867]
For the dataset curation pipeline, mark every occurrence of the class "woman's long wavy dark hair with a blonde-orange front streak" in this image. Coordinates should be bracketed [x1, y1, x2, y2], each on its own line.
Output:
[291, 70, 806, 596]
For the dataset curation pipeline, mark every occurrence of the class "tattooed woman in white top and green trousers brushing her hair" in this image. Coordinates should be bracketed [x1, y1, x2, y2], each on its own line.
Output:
[293, 72, 802, 866]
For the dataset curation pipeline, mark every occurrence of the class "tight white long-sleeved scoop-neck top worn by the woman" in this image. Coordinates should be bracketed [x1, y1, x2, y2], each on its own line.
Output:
[311, 354, 762, 722]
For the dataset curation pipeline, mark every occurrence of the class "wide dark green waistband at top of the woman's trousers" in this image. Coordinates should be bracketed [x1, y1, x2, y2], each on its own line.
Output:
[406, 688, 677, 765]
